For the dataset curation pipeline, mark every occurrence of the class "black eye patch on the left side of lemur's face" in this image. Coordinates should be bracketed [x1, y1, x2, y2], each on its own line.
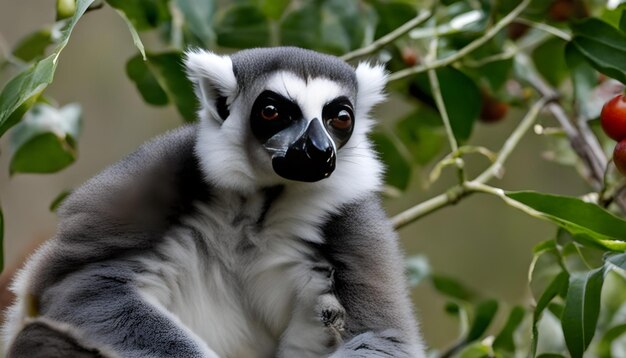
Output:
[250, 91, 302, 143]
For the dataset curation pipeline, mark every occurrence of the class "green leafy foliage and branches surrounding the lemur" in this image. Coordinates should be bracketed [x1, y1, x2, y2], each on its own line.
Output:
[0, 0, 626, 357]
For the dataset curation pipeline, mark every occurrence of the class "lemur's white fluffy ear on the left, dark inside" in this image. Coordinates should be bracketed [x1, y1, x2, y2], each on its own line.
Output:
[185, 49, 237, 122]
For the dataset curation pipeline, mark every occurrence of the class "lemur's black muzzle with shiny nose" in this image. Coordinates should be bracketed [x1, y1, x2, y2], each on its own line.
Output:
[272, 118, 336, 182]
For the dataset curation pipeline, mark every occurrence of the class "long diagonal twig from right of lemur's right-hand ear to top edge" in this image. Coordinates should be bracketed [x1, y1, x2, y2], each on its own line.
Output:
[389, 0, 531, 82]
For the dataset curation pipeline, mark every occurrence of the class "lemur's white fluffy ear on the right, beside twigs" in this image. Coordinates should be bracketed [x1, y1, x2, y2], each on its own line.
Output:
[355, 62, 387, 114]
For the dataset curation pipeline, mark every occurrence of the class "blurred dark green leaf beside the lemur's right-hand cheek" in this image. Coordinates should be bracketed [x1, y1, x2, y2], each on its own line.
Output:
[370, 132, 411, 191]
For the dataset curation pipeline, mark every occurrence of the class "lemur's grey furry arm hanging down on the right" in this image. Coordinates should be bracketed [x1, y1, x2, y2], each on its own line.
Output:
[324, 196, 424, 358]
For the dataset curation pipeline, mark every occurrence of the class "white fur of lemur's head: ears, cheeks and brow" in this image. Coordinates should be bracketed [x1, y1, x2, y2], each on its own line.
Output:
[186, 51, 386, 208]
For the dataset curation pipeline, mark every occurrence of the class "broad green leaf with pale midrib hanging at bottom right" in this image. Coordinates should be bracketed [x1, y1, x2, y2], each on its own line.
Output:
[561, 268, 604, 358]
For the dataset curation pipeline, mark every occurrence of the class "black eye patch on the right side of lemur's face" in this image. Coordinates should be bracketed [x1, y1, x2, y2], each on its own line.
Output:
[322, 96, 354, 148]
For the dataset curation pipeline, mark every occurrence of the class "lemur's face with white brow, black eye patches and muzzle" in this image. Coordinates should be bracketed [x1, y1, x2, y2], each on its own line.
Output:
[250, 72, 355, 182]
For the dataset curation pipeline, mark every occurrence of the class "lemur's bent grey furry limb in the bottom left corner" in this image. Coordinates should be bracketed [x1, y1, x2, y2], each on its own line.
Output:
[8, 261, 218, 358]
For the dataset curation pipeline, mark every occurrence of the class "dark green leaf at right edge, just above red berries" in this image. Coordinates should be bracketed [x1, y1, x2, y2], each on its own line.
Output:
[571, 18, 626, 83]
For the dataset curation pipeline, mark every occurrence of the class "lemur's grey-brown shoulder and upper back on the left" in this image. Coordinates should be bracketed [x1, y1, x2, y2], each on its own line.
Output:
[33, 125, 211, 292]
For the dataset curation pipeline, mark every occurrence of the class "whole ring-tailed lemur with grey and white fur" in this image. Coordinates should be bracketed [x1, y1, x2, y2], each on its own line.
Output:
[5, 48, 423, 358]
